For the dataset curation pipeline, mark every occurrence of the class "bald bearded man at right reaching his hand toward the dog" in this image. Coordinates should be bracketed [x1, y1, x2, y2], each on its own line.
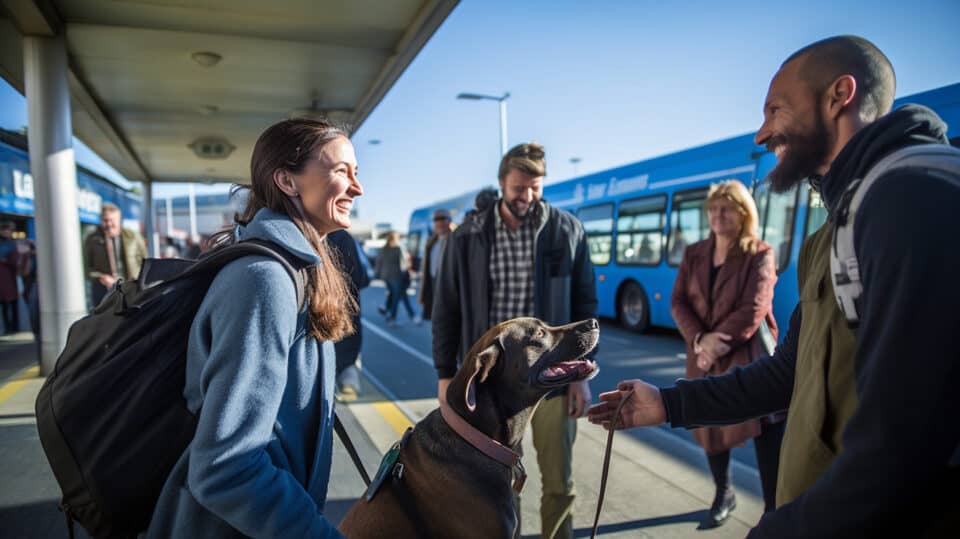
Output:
[589, 35, 960, 539]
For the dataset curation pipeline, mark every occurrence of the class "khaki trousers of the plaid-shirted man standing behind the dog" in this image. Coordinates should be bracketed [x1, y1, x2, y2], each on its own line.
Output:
[515, 395, 577, 539]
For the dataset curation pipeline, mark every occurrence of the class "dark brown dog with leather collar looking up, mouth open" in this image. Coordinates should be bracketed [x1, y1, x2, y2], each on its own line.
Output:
[340, 318, 600, 539]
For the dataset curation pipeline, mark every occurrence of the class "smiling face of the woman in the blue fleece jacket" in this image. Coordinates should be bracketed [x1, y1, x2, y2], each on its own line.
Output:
[293, 137, 363, 235]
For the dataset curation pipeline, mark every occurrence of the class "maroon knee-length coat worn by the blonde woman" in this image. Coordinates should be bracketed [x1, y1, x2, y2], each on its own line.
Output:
[670, 234, 777, 455]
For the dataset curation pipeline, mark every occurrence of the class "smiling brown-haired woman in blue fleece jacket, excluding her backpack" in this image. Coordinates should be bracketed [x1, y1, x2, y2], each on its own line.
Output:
[146, 119, 363, 538]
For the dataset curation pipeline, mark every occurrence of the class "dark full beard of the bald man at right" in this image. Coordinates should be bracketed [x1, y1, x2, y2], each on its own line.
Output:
[767, 114, 832, 193]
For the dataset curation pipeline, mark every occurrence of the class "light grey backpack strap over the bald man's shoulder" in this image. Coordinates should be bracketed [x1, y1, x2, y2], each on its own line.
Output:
[830, 144, 960, 329]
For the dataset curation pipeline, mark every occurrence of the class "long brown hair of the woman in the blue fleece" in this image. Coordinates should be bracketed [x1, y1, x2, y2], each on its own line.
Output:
[208, 118, 358, 341]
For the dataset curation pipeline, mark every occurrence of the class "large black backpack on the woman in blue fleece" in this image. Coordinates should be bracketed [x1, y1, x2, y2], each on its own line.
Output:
[36, 241, 306, 538]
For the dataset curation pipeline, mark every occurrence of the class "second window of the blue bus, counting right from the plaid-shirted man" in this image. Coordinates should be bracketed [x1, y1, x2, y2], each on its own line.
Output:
[617, 196, 667, 266]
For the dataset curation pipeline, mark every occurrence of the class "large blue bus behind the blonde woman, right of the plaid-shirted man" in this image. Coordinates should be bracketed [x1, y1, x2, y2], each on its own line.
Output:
[410, 84, 960, 331]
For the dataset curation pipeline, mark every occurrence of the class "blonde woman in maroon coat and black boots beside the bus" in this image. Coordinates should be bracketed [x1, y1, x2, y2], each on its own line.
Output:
[670, 180, 783, 528]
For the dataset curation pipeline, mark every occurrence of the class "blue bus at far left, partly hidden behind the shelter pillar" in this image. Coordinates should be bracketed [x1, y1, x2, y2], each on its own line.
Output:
[0, 130, 143, 238]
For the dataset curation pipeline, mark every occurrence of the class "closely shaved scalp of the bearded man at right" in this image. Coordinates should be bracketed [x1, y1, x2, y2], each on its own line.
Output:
[781, 36, 897, 123]
